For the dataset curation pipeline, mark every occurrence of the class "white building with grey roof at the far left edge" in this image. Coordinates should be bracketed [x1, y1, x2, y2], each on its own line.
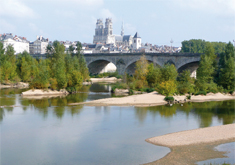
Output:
[0, 33, 29, 54]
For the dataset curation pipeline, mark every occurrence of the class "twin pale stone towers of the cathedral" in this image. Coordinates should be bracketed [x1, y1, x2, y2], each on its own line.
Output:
[93, 18, 115, 44]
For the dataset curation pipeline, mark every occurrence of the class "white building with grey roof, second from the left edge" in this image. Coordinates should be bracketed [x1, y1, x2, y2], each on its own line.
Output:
[29, 36, 49, 54]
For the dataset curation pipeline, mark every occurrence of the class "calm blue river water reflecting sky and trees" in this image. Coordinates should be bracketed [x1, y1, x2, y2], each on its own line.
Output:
[0, 84, 235, 165]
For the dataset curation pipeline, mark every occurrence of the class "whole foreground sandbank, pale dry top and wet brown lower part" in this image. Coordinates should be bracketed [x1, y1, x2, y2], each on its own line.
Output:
[146, 124, 235, 165]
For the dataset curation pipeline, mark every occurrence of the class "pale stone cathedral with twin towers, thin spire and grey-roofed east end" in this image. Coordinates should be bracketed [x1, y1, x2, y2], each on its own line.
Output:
[93, 18, 141, 49]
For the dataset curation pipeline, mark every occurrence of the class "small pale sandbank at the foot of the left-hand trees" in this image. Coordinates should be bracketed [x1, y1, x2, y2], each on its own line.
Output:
[22, 89, 68, 96]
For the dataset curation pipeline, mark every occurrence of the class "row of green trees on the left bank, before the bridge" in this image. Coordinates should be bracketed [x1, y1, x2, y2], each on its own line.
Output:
[0, 41, 89, 91]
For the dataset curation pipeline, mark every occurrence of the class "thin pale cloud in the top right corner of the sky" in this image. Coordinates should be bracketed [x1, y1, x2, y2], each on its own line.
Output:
[173, 0, 235, 16]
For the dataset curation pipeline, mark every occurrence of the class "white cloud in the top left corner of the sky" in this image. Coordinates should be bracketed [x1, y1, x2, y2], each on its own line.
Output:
[0, 0, 36, 18]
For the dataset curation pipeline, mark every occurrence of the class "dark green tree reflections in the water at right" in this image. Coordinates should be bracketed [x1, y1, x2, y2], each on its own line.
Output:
[135, 100, 235, 128]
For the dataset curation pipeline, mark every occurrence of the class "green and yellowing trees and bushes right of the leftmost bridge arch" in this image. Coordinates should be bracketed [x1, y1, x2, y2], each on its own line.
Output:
[112, 41, 235, 101]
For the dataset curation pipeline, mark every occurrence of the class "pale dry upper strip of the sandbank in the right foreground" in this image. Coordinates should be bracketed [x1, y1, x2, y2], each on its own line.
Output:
[146, 124, 235, 147]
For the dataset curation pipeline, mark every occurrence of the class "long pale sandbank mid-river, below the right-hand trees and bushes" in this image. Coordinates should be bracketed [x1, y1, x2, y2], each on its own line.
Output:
[69, 92, 235, 107]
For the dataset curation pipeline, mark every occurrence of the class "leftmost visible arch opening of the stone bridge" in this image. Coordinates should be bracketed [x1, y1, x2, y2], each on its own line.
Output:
[87, 58, 117, 74]
